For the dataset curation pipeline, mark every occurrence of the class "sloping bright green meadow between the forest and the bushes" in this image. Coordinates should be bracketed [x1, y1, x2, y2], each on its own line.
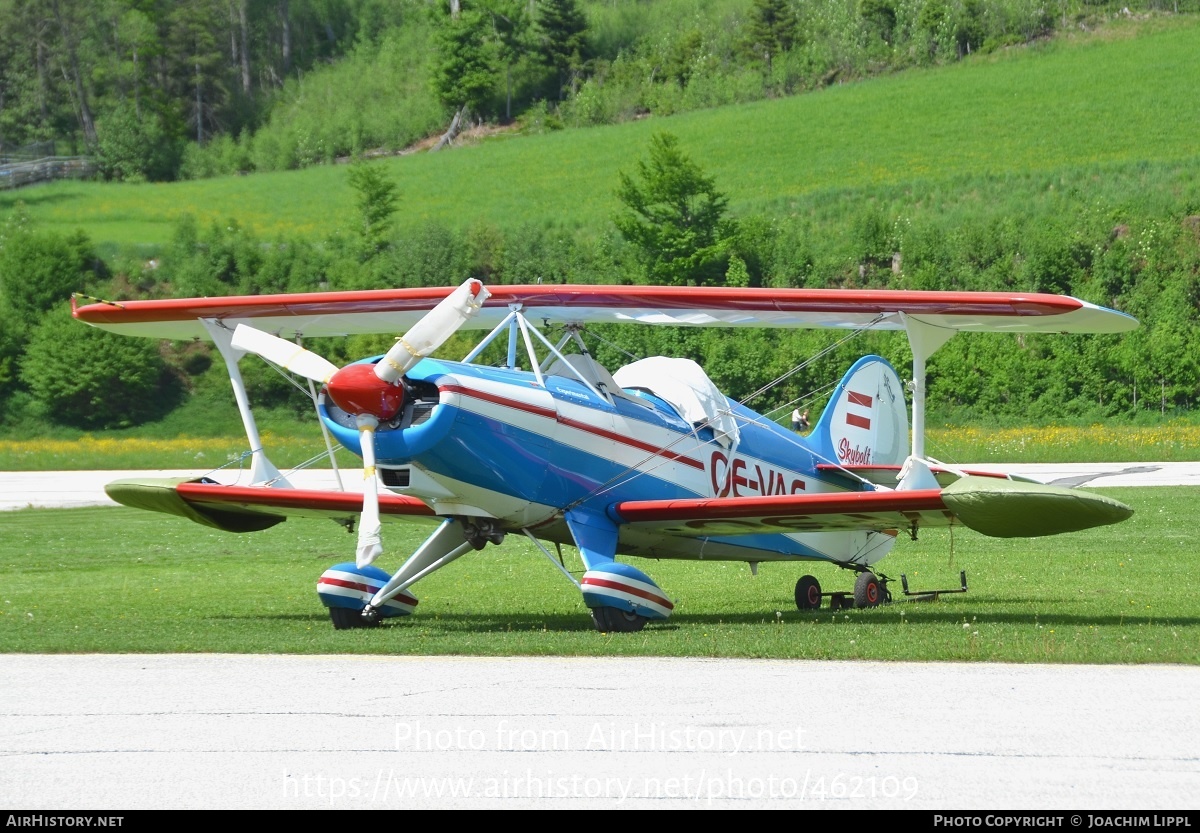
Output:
[0, 18, 1200, 245]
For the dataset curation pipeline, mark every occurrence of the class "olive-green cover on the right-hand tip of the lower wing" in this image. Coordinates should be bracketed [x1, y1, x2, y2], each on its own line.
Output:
[942, 477, 1133, 538]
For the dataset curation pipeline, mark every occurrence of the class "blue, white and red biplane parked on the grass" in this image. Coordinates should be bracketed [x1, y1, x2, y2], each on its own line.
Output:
[74, 280, 1138, 633]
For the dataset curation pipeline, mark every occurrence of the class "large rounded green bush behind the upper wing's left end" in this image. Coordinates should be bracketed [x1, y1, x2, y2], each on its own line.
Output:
[20, 306, 178, 429]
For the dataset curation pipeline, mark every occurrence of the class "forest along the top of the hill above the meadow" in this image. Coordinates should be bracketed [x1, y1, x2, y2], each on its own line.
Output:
[7, 0, 1200, 180]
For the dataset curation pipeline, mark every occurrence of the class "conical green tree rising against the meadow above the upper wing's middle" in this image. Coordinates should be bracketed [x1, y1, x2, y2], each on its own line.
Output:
[613, 133, 737, 286]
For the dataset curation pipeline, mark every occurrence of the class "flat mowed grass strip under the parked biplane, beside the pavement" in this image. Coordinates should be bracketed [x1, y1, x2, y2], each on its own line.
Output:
[0, 487, 1200, 664]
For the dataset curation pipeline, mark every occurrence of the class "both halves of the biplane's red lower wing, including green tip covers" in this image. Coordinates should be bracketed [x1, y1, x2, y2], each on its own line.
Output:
[104, 477, 1133, 538]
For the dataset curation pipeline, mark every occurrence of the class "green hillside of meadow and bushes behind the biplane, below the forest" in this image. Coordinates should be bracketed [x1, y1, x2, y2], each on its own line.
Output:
[0, 17, 1200, 436]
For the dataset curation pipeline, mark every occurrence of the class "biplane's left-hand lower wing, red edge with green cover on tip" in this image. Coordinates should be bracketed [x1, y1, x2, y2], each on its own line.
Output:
[104, 478, 436, 532]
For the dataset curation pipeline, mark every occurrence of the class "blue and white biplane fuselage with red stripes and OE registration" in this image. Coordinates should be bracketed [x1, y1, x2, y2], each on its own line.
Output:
[322, 359, 890, 563]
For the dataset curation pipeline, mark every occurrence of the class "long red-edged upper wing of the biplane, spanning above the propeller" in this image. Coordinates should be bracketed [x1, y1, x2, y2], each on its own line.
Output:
[74, 284, 1138, 340]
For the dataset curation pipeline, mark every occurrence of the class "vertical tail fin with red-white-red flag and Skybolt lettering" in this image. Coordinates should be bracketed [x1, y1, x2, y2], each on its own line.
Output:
[809, 355, 910, 466]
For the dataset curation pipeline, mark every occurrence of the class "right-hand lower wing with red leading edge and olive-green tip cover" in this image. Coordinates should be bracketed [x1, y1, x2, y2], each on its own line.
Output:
[612, 477, 1133, 538]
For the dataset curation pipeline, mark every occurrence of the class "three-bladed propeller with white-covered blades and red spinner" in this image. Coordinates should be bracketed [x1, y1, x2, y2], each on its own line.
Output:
[233, 278, 492, 568]
